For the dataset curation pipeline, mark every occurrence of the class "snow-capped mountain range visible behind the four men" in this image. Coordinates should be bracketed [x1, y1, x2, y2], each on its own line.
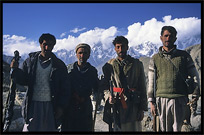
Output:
[3, 38, 201, 75]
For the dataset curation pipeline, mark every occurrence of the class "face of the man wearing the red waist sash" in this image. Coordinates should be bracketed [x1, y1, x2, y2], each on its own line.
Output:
[115, 44, 128, 59]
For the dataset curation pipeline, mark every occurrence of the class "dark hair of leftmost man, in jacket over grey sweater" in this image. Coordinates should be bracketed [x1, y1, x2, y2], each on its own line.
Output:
[39, 33, 56, 46]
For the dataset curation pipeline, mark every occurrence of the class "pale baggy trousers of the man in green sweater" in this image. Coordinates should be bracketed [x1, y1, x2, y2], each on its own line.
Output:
[156, 97, 188, 132]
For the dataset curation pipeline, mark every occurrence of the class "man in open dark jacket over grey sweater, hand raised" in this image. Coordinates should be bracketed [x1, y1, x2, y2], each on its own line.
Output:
[11, 33, 70, 131]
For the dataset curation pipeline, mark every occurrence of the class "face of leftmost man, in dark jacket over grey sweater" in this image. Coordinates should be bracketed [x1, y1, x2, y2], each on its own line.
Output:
[40, 40, 54, 56]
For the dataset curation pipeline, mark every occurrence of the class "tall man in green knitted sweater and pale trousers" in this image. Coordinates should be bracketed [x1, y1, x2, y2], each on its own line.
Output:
[148, 26, 200, 132]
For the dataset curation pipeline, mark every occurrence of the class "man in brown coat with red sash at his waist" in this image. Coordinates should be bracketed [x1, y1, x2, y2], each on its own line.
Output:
[102, 36, 147, 131]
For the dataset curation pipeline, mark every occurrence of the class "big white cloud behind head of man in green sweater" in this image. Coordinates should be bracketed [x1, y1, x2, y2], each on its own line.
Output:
[126, 15, 201, 46]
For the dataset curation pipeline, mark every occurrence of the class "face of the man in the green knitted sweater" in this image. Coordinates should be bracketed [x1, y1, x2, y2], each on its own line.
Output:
[160, 30, 177, 47]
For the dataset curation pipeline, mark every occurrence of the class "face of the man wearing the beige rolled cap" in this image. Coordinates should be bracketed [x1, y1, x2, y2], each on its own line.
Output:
[76, 47, 90, 64]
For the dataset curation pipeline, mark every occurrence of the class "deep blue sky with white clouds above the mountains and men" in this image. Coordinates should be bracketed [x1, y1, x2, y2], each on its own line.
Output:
[3, 3, 201, 54]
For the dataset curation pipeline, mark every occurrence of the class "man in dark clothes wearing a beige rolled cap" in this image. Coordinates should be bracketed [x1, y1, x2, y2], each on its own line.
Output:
[62, 43, 98, 131]
